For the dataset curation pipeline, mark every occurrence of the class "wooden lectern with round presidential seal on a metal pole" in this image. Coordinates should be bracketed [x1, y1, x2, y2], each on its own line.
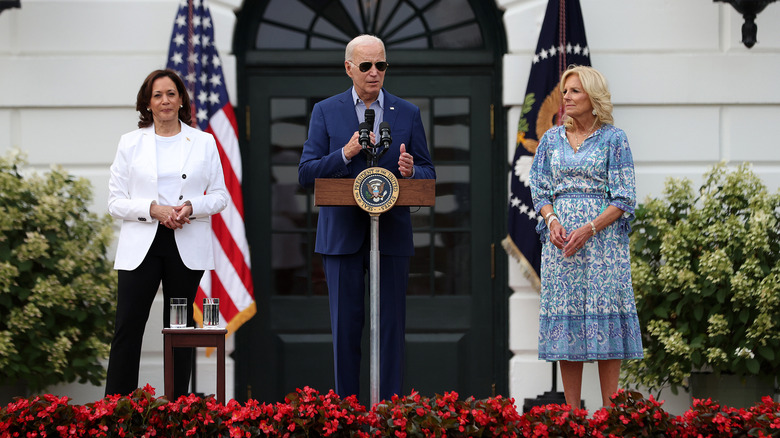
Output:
[314, 173, 436, 406]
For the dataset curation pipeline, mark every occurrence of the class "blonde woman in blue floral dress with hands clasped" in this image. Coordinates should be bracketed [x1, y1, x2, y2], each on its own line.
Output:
[530, 66, 642, 408]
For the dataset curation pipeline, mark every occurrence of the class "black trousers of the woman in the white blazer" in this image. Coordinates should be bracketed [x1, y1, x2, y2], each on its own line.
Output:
[106, 225, 204, 398]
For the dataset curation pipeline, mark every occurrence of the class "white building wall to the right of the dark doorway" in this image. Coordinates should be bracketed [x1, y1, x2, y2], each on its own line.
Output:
[496, 0, 780, 413]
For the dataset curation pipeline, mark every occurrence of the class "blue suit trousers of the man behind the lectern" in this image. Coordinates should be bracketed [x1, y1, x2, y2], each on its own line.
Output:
[322, 238, 409, 400]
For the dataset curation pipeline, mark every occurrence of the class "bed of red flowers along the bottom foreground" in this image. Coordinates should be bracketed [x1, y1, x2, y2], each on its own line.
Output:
[0, 386, 780, 438]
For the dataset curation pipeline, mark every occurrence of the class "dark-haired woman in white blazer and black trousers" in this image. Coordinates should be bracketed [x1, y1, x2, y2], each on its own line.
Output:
[106, 70, 228, 397]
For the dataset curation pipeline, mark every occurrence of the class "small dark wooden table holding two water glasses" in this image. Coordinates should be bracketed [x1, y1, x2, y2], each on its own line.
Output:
[163, 328, 227, 404]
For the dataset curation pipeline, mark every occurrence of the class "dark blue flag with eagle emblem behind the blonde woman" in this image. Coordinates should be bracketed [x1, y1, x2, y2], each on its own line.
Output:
[503, 0, 590, 290]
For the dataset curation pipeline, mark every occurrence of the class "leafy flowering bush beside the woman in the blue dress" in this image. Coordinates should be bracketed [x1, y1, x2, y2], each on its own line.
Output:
[623, 163, 780, 401]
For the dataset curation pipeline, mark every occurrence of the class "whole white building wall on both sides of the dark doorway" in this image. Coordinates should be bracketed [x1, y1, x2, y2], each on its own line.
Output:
[0, 0, 780, 412]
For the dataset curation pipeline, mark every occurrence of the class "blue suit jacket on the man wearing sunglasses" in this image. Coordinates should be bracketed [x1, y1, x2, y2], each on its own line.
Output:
[298, 88, 436, 256]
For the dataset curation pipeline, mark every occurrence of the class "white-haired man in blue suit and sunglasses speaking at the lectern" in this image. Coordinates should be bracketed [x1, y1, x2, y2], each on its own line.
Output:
[298, 35, 436, 400]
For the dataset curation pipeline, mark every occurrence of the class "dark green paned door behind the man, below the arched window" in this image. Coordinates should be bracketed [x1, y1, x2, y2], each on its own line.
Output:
[236, 68, 506, 402]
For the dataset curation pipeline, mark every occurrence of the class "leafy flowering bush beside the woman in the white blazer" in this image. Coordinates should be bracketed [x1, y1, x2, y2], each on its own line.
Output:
[0, 153, 115, 397]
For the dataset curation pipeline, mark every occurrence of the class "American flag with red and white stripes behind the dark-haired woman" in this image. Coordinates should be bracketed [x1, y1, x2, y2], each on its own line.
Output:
[168, 0, 256, 334]
